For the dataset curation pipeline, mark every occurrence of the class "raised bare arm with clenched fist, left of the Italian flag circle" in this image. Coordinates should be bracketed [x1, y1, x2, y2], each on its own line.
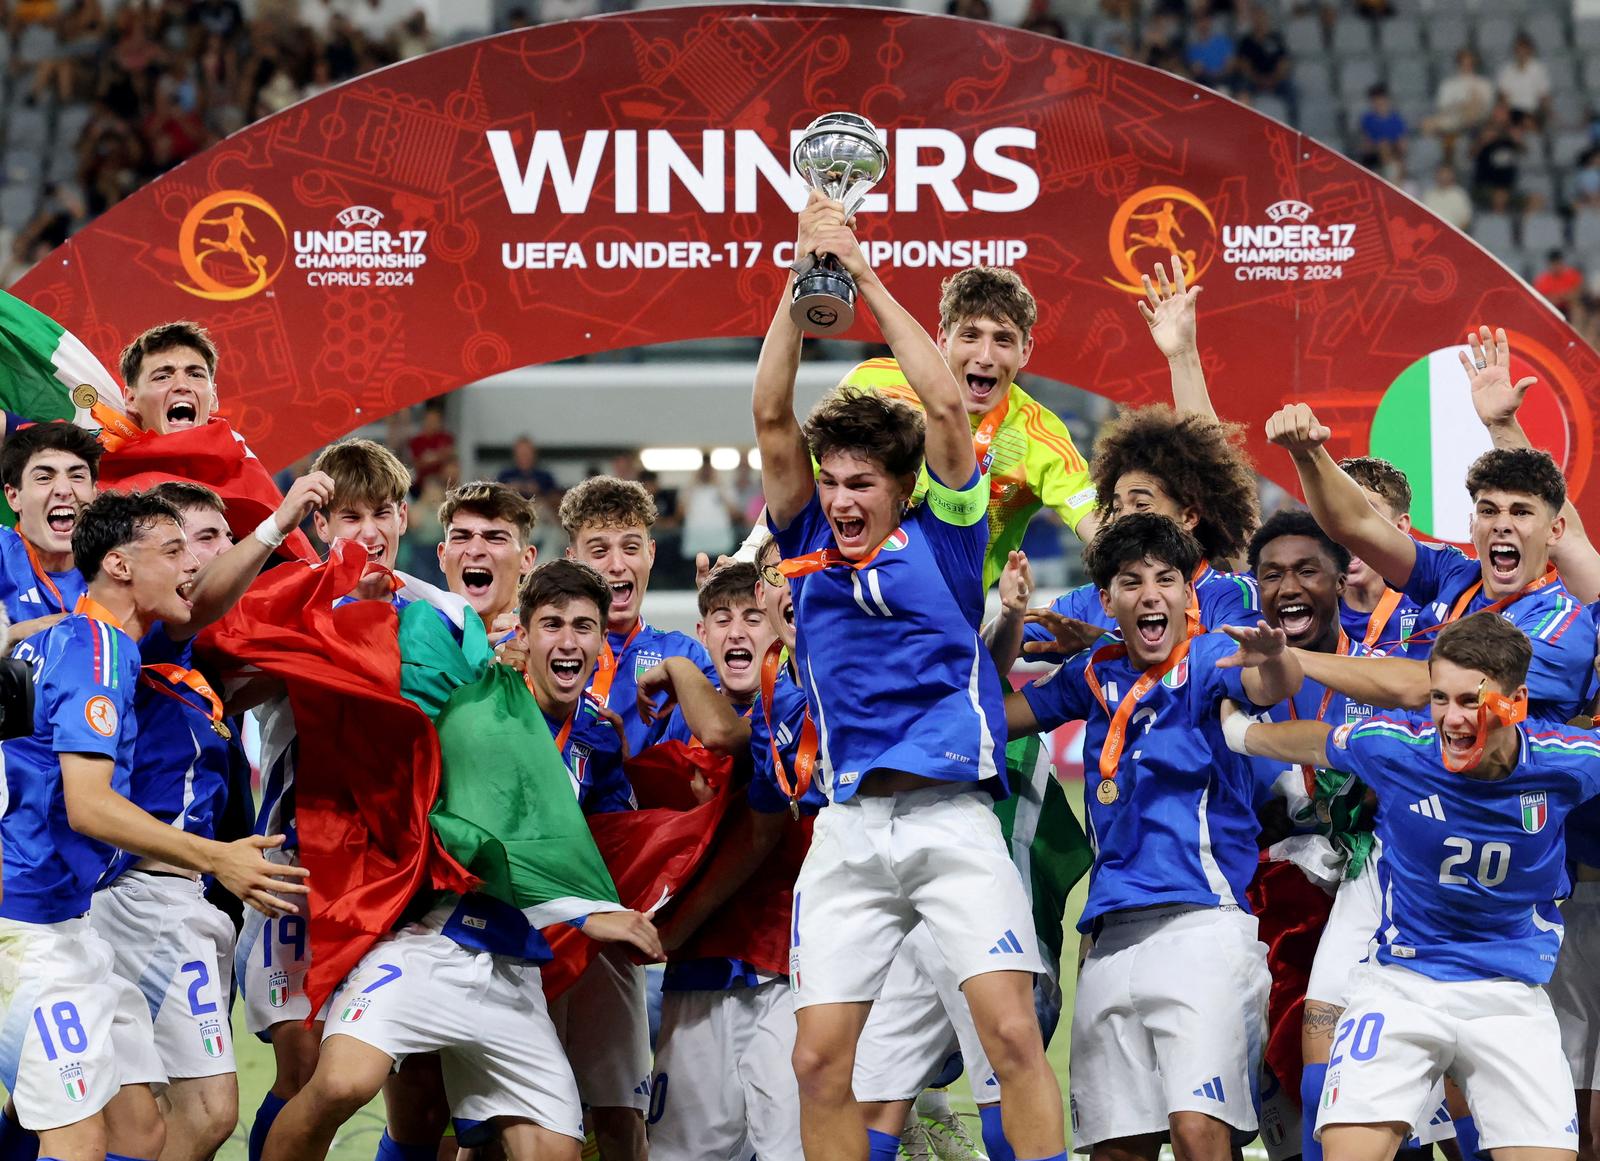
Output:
[1267, 403, 1416, 588]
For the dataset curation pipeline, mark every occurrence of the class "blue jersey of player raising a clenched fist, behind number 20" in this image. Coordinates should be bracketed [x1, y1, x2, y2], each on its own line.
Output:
[1405, 544, 1595, 721]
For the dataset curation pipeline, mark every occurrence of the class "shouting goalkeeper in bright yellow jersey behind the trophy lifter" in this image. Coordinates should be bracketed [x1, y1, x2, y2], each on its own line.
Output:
[838, 265, 1099, 588]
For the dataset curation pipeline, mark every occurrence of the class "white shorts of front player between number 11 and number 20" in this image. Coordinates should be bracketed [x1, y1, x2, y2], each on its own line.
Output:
[1070, 907, 1272, 1153]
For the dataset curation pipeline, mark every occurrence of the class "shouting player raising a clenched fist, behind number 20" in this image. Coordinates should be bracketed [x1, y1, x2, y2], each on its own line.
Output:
[1267, 403, 1595, 721]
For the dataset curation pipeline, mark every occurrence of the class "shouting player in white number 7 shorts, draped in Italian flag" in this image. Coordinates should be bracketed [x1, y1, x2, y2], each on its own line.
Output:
[264, 560, 661, 1161]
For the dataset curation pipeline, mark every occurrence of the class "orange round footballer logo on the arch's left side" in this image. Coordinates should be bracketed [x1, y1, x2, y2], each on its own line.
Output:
[176, 189, 290, 302]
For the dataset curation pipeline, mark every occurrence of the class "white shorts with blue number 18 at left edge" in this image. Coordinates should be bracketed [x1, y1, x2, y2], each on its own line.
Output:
[0, 916, 166, 1132]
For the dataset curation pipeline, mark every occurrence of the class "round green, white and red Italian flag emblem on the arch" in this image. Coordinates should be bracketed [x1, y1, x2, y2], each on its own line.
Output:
[1368, 345, 1568, 544]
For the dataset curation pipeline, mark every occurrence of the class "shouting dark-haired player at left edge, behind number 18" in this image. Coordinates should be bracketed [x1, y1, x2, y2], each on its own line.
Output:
[0, 422, 101, 643]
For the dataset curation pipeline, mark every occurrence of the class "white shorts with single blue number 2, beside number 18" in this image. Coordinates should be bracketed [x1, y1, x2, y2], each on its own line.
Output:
[90, 870, 235, 1078]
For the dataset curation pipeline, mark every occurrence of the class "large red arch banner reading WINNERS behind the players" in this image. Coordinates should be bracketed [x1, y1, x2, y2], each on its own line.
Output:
[18, 5, 1600, 534]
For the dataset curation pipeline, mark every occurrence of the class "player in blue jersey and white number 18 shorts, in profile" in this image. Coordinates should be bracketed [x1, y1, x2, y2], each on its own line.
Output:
[0, 493, 307, 1161]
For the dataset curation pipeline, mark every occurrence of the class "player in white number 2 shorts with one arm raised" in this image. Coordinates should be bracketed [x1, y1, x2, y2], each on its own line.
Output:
[75, 473, 333, 1161]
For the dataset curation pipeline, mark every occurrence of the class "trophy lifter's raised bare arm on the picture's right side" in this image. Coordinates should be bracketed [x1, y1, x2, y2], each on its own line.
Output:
[812, 209, 978, 488]
